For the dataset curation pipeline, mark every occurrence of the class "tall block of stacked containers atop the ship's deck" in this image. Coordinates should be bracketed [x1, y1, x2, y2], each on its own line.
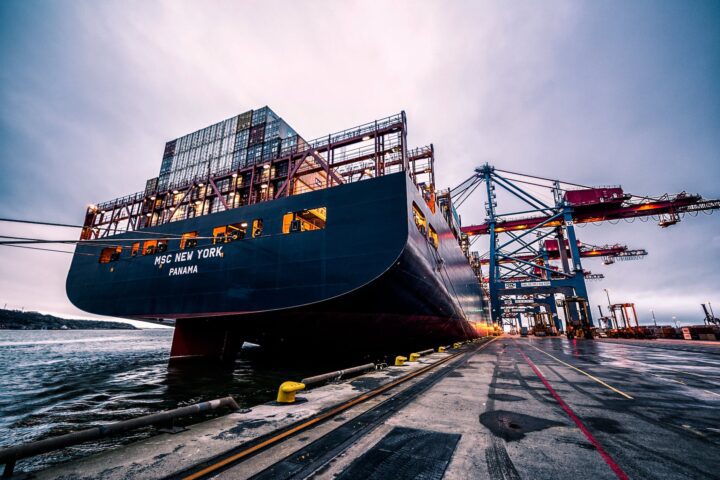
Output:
[155, 107, 307, 192]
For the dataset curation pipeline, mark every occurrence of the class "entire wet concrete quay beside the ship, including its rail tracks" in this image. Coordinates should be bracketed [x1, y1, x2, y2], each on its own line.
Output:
[9, 335, 720, 479]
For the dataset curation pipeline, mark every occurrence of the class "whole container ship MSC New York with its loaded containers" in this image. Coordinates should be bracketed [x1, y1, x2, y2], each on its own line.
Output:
[66, 107, 488, 360]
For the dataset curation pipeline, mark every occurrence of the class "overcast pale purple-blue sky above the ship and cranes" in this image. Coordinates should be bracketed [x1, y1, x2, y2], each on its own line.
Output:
[0, 0, 720, 323]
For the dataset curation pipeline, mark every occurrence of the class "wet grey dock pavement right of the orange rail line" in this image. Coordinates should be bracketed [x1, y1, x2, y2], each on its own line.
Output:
[211, 336, 720, 480]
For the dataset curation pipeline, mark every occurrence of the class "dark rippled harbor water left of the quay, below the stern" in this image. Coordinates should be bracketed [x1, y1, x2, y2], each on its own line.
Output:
[0, 329, 317, 471]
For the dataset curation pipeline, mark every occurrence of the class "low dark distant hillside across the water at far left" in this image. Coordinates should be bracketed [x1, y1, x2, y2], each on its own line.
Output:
[0, 309, 138, 330]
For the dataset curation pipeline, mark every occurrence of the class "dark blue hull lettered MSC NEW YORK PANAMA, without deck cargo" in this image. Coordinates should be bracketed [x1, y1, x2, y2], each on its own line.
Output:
[67, 172, 487, 358]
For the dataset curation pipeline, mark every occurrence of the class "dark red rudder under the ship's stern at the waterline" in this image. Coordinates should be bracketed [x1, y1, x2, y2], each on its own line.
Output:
[170, 319, 243, 364]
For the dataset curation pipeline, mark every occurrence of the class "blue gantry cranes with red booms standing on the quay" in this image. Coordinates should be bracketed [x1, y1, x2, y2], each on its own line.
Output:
[449, 164, 720, 338]
